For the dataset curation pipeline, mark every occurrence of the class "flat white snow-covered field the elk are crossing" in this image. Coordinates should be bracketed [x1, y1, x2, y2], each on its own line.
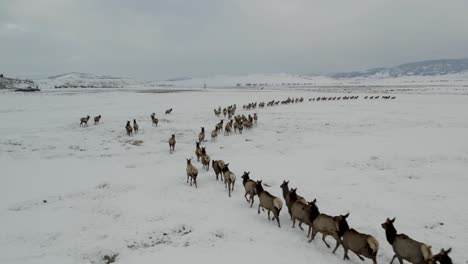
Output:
[0, 89, 468, 264]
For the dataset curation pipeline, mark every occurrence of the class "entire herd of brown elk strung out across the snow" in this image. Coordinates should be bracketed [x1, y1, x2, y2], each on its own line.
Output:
[80, 93, 452, 264]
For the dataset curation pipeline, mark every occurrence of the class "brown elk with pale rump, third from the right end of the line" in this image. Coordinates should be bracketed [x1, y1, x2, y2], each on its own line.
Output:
[338, 213, 379, 264]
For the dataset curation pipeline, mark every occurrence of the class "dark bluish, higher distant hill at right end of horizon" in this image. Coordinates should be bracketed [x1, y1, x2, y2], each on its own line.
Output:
[331, 59, 468, 79]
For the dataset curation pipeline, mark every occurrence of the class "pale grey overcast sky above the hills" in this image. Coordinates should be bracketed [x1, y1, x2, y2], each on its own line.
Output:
[0, 0, 468, 79]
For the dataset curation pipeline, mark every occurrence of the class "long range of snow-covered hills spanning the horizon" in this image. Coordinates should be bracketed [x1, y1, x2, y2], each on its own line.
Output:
[30, 59, 468, 89]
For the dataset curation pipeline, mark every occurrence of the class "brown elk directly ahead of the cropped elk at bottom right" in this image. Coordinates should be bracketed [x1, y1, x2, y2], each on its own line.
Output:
[382, 218, 432, 264]
